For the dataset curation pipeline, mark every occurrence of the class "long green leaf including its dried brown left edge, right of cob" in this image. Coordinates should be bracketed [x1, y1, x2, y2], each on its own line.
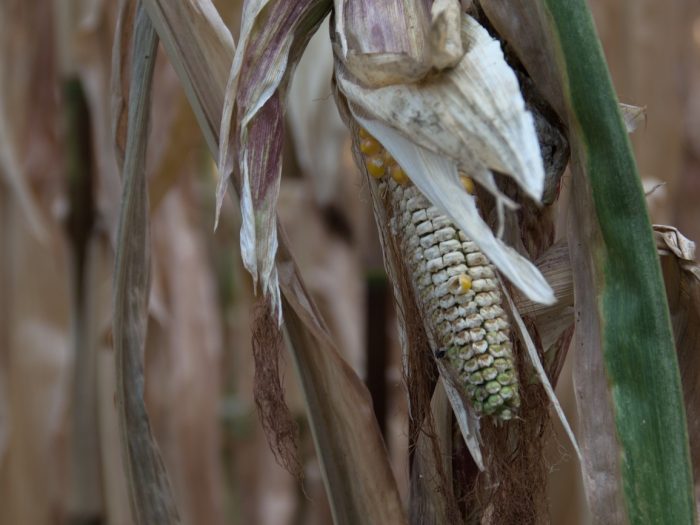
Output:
[536, 0, 695, 523]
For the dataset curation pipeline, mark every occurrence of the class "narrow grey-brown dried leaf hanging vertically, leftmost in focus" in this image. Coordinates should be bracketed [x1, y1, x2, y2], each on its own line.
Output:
[113, 5, 180, 525]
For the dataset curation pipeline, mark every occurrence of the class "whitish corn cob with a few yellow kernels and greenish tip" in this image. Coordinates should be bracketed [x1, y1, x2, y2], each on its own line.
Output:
[360, 130, 520, 421]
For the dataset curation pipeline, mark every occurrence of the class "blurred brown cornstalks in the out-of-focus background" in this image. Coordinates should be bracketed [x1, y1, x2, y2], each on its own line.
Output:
[0, 0, 700, 525]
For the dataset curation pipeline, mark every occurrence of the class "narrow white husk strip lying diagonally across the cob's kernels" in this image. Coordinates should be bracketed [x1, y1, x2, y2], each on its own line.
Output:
[355, 115, 555, 304]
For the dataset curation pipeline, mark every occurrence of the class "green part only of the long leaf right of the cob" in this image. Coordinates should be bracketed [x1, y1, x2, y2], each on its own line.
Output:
[543, 0, 695, 524]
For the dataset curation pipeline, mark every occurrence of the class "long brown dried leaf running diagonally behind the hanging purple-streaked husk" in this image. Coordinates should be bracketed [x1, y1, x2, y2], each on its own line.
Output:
[146, 0, 406, 524]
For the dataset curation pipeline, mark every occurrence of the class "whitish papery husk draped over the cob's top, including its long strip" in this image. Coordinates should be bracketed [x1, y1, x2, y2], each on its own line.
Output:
[336, 16, 554, 303]
